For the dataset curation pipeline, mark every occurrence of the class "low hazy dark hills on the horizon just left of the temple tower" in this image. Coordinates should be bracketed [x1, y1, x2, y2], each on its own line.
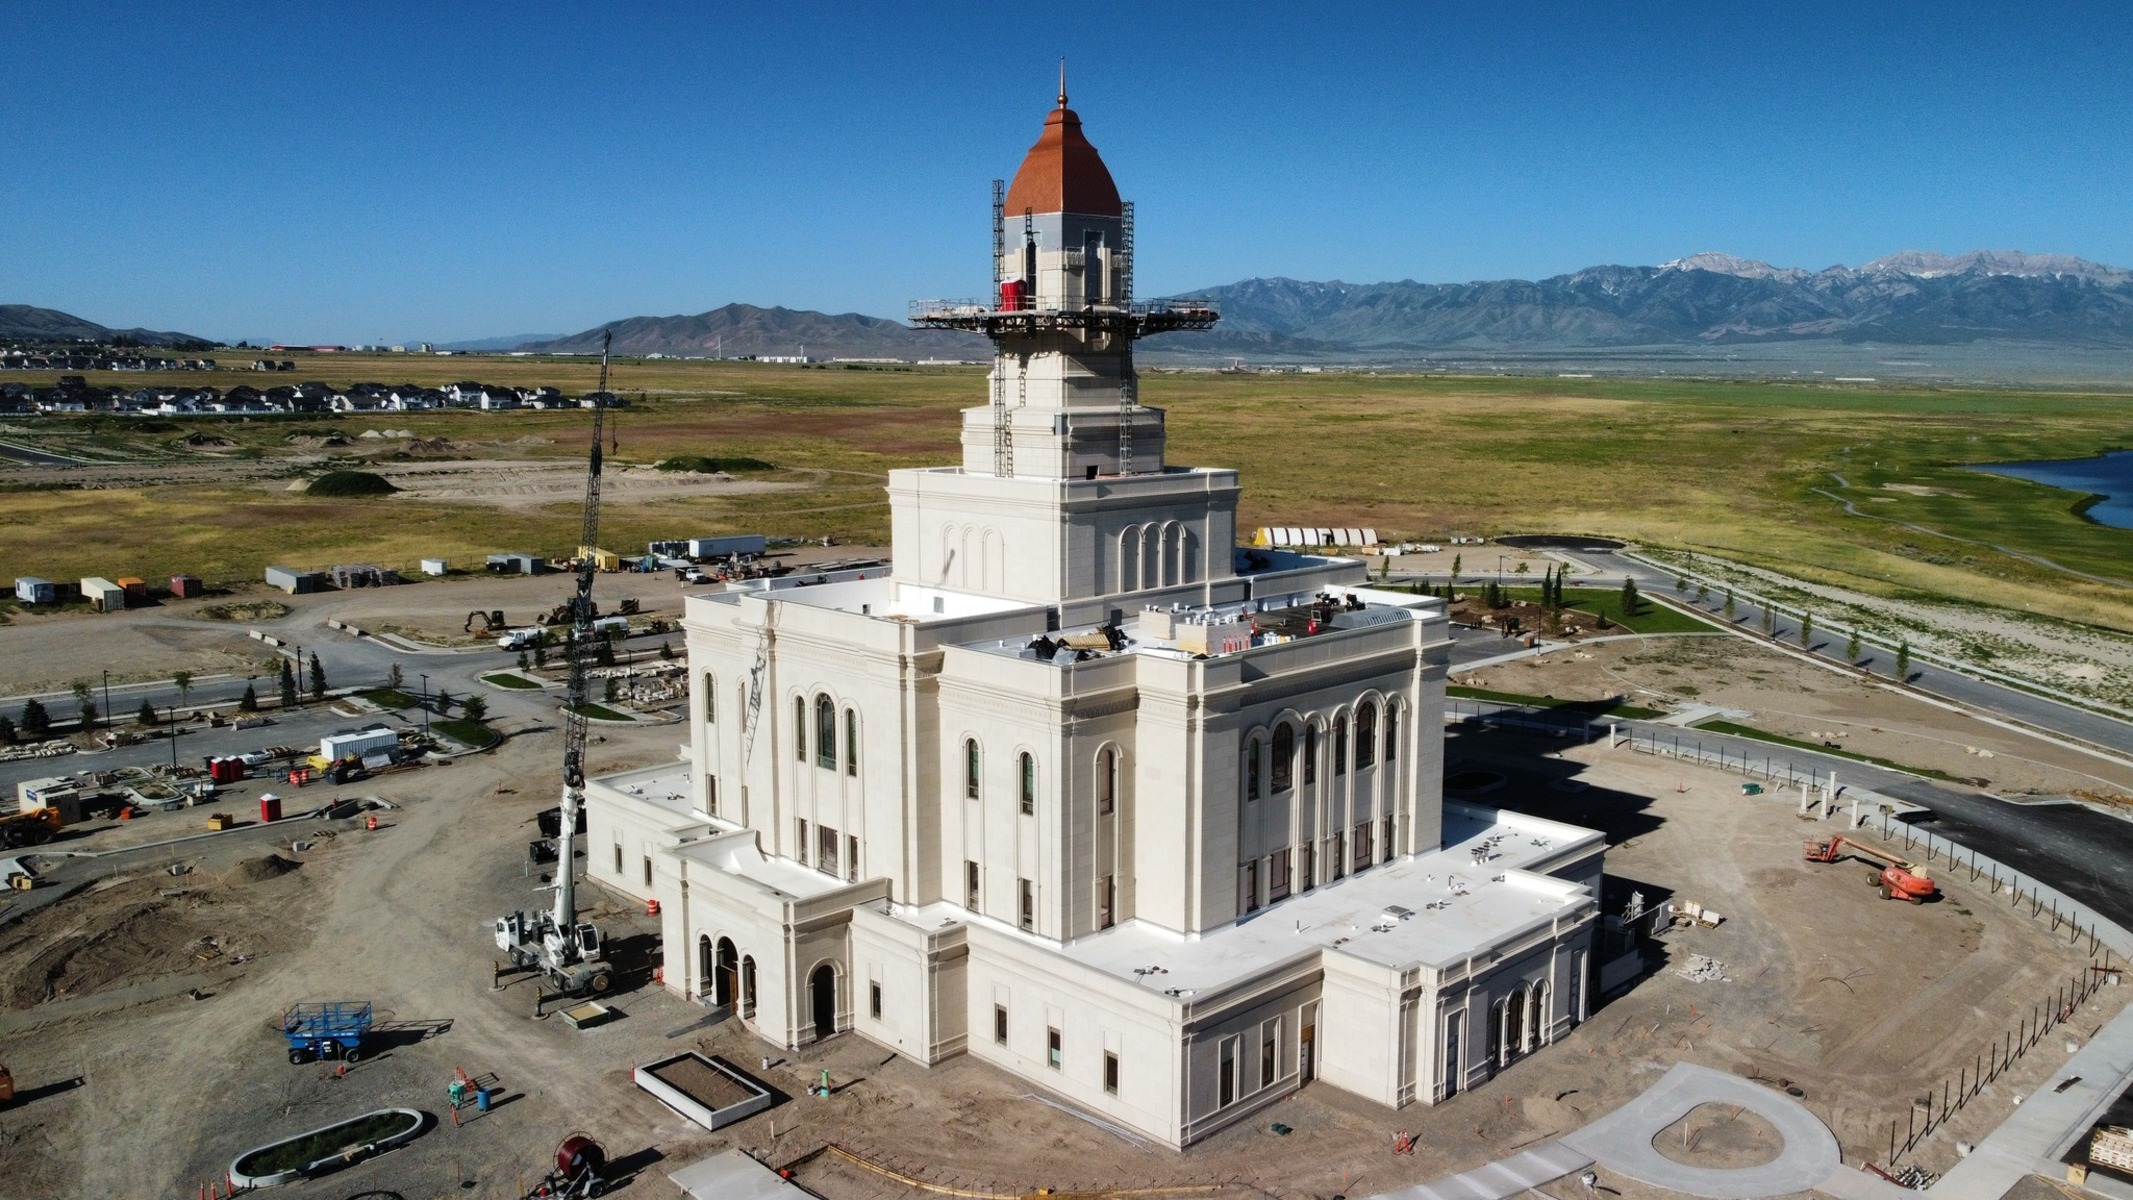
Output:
[516, 305, 992, 358]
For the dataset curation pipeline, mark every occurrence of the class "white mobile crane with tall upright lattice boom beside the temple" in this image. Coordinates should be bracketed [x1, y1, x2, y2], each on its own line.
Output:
[497, 330, 614, 995]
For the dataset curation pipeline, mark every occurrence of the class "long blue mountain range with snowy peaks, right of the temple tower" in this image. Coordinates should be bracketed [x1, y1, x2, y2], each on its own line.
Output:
[1148, 252, 2133, 356]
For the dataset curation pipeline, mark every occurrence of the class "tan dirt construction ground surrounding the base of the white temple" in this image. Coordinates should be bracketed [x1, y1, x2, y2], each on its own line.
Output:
[0, 729, 2122, 1200]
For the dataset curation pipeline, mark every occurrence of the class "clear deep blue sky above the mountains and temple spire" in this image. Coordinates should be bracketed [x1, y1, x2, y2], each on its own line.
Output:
[0, 0, 2133, 341]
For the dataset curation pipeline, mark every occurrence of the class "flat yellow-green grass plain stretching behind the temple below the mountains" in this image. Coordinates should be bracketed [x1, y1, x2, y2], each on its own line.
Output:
[0, 354, 2133, 629]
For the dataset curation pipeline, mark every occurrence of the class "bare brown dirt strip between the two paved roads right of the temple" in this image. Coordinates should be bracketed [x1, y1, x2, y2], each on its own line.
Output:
[1453, 637, 2133, 795]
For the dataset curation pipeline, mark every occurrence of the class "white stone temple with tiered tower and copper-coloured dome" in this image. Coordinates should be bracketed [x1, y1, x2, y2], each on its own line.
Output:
[587, 96, 1604, 1147]
